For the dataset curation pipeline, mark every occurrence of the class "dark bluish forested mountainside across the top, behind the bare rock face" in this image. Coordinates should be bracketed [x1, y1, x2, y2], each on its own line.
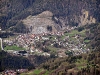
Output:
[0, 0, 100, 32]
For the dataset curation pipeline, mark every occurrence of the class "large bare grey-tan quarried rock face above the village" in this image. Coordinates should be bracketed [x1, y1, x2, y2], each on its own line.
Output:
[22, 11, 57, 34]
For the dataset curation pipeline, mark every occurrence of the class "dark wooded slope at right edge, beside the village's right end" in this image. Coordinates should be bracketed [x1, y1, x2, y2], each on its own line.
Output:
[85, 23, 100, 51]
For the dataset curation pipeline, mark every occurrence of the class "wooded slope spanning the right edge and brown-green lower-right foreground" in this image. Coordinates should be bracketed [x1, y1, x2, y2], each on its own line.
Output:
[21, 23, 100, 75]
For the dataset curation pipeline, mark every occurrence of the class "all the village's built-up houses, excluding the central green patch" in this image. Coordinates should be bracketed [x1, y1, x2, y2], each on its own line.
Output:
[4, 27, 89, 57]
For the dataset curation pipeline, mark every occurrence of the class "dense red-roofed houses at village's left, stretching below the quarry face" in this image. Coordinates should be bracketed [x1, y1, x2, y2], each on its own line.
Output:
[14, 32, 63, 50]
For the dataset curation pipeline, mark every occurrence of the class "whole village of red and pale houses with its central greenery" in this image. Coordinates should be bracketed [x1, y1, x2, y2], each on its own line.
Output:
[0, 25, 89, 57]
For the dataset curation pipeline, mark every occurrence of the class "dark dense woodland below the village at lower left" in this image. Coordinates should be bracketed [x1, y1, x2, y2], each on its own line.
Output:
[0, 51, 34, 72]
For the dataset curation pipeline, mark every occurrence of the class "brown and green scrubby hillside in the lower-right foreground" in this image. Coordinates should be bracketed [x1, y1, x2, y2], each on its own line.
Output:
[21, 52, 100, 75]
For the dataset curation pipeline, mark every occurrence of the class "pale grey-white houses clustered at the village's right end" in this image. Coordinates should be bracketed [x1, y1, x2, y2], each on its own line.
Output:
[66, 36, 90, 55]
